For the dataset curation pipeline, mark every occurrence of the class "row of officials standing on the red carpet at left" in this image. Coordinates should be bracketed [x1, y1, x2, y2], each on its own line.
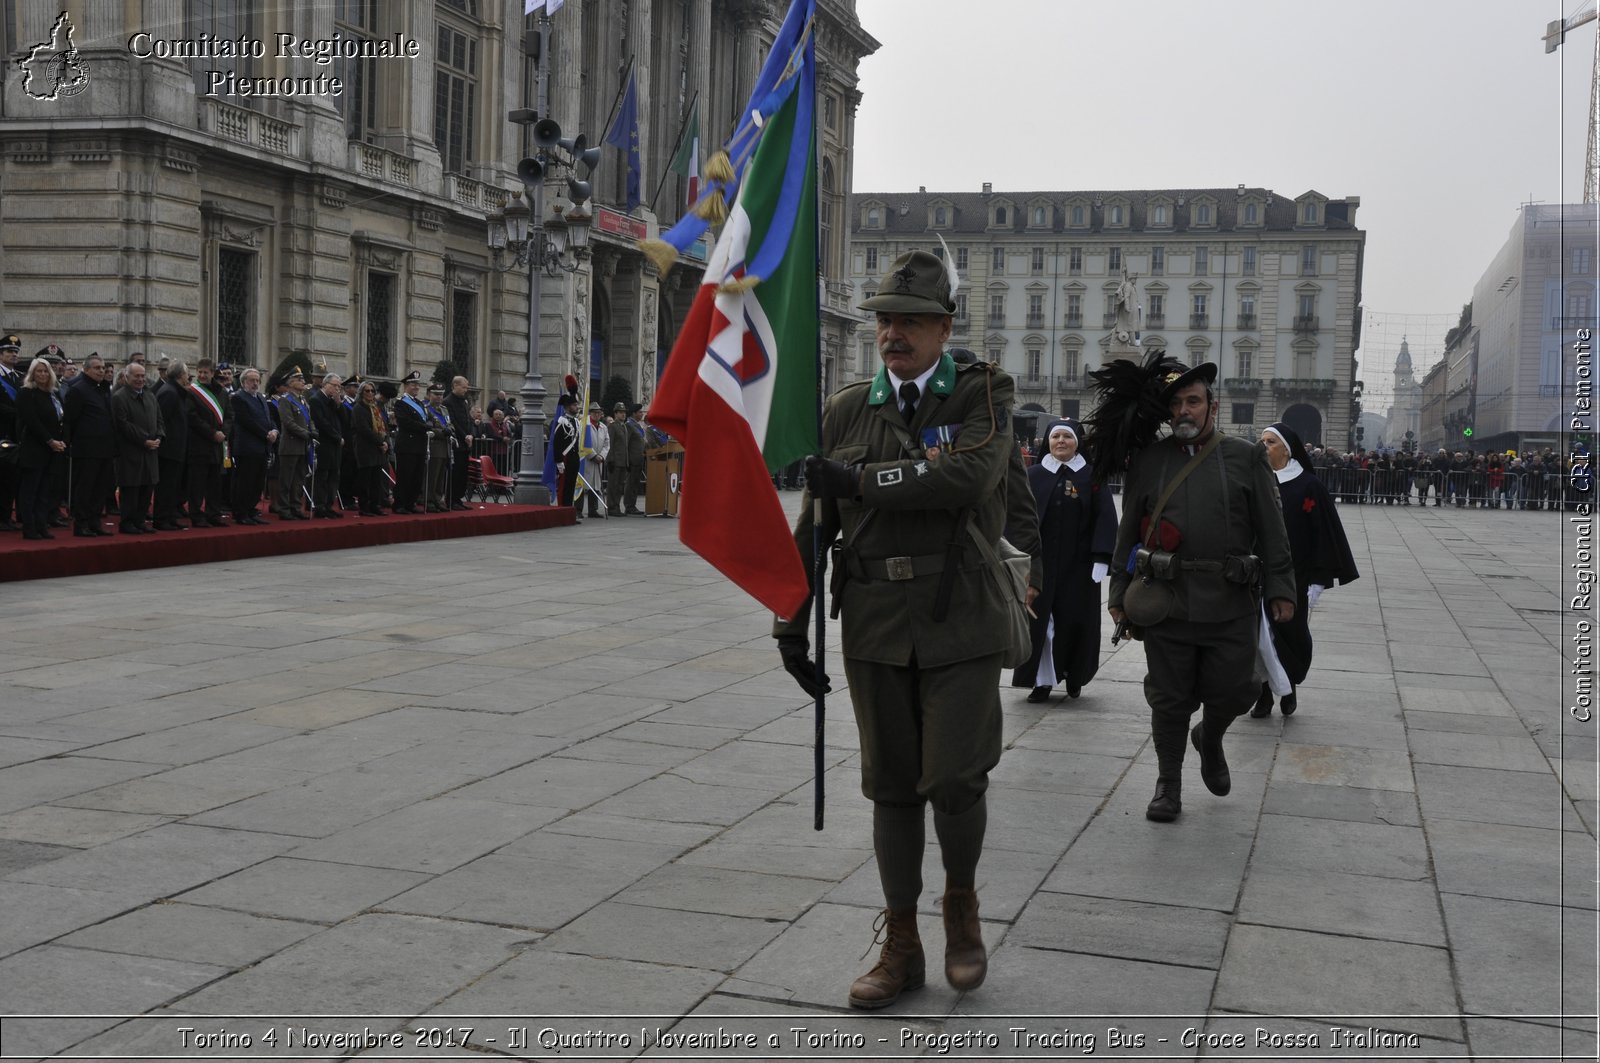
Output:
[0, 335, 547, 540]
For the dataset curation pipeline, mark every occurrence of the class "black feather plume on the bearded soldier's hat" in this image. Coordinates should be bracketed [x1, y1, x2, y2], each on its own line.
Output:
[1080, 347, 1216, 483]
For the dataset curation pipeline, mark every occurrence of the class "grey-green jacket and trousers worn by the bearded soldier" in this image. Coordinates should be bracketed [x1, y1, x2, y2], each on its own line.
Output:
[1107, 429, 1296, 806]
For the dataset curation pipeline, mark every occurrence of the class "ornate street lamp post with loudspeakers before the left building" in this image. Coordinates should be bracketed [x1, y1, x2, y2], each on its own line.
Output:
[488, 11, 600, 506]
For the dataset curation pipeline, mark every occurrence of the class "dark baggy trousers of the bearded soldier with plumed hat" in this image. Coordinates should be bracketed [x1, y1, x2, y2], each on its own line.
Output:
[1144, 613, 1261, 783]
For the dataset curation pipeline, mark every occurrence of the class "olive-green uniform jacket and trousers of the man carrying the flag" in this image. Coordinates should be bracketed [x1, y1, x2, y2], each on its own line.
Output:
[774, 354, 1013, 890]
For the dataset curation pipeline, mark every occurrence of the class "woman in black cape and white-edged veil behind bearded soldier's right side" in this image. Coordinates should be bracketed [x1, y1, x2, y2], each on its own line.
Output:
[1250, 421, 1360, 719]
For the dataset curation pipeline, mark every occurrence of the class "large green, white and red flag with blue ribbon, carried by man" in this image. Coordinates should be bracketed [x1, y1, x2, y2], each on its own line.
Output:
[650, 12, 819, 618]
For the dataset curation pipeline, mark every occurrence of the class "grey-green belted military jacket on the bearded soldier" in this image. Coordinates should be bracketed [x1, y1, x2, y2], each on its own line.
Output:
[1106, 435, 1294, 621]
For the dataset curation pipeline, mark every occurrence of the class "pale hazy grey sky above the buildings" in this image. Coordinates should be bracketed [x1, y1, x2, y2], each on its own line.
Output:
[854, 0, 1597, 393]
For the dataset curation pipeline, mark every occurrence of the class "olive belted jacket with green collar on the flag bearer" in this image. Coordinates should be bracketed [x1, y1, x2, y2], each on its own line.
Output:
[773, 354, 1016, 666]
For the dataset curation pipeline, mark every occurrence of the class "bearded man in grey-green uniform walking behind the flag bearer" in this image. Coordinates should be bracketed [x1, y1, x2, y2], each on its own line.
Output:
[1107, 362, 1296, 823]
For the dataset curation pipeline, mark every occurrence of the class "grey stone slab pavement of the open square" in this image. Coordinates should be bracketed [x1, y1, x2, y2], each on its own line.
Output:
[0, 495, 1600, 1058]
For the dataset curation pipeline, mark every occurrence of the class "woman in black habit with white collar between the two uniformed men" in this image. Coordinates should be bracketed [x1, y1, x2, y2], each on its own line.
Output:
[1011, 418, 1117, 701]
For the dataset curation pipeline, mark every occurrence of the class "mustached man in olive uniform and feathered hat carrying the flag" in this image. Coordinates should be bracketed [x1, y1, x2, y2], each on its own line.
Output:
[773, 251, 1013, 1009]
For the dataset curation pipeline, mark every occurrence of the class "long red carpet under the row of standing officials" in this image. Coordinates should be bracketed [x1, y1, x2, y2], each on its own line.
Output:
[0, 503, 576, 583]
